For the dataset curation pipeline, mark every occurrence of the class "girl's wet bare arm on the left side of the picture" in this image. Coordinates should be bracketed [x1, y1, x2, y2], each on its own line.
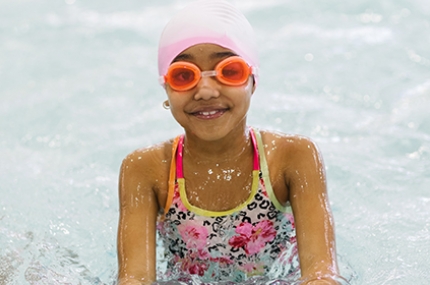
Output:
[117, 154, 158, 285]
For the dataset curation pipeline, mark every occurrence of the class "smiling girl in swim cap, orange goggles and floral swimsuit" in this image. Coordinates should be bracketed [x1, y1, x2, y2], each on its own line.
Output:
[118, 0, 346, 284]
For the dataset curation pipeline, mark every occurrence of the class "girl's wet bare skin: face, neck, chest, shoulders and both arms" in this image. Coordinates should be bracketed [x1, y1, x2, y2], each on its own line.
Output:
[118, 44, 338, 284]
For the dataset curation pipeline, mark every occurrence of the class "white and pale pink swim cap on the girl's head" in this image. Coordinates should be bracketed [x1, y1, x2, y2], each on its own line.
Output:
[158, 0, 258, 82]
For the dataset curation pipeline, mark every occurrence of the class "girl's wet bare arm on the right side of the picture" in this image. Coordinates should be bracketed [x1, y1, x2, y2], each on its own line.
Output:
[286, 138, 339, 285]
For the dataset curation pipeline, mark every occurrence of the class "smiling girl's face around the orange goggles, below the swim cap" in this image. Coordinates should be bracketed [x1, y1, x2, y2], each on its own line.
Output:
[166, 44, 255, 141]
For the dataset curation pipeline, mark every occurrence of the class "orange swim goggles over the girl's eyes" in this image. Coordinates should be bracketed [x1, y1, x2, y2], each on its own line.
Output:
[160, 56, 254, 91]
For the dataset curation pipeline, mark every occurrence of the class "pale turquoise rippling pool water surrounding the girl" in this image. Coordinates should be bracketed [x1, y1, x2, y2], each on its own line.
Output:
[0, 0, 430, 285]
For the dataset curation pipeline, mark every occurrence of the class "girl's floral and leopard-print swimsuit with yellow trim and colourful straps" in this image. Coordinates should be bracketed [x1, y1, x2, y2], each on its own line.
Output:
[157, 129, 300, 282]
